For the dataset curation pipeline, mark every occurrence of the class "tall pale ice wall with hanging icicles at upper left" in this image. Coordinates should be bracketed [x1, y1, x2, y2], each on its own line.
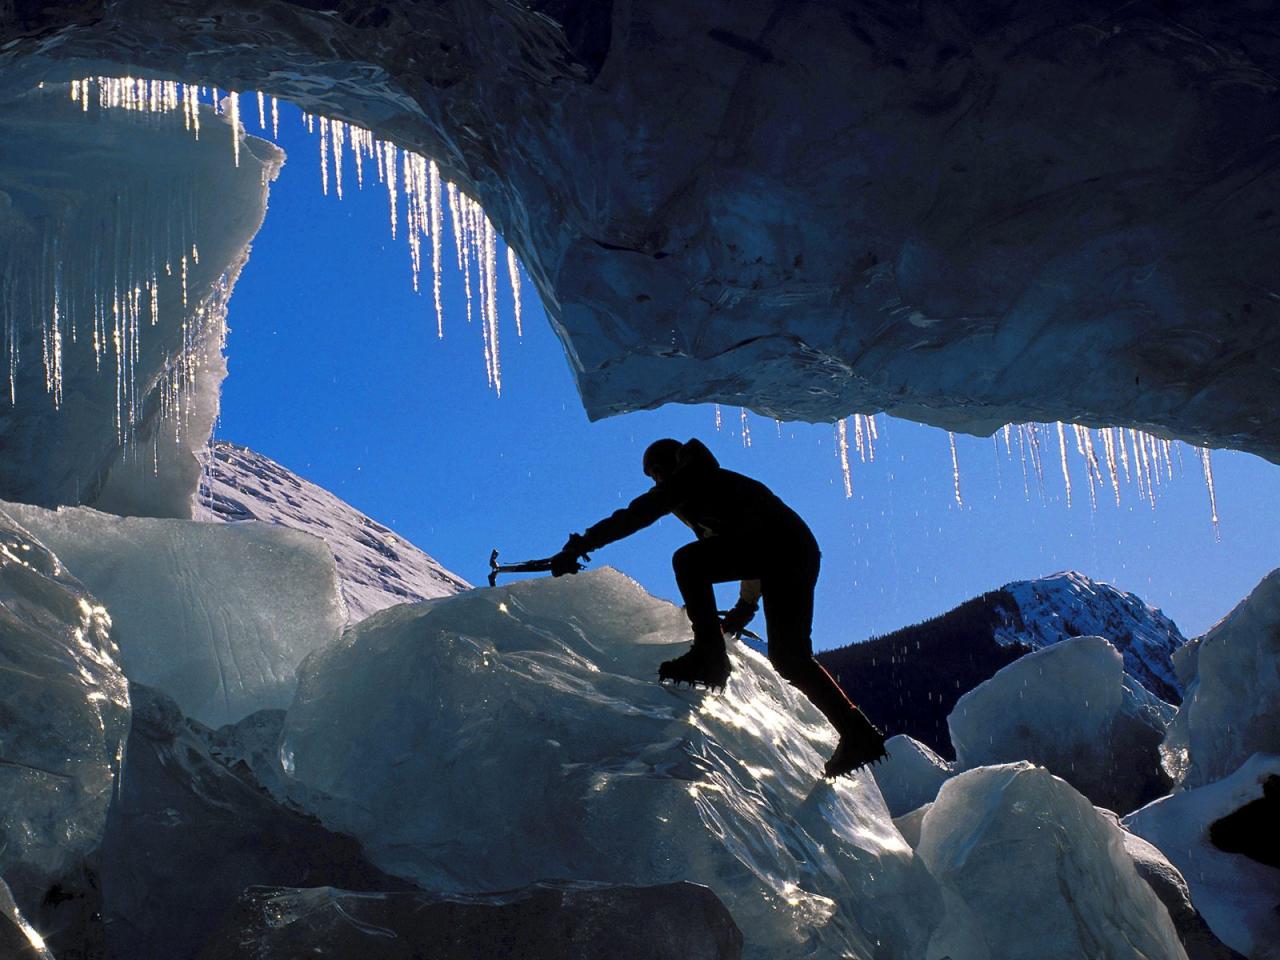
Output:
[0, 82, 283, 517]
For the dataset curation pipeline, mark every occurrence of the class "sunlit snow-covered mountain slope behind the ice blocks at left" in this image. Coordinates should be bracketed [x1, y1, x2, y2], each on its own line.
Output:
[196, 440, 471, 622]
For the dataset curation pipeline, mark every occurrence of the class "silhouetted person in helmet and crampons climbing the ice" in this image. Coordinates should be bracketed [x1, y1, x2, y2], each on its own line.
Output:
[552, 439, 884, 777]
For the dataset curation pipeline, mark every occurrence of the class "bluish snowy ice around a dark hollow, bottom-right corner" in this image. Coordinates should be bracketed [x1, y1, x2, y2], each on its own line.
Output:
[1124, 754, 1280, 960]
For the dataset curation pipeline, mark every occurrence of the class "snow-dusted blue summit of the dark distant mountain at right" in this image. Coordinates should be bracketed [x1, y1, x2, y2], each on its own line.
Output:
[993, 571, 1187, 703]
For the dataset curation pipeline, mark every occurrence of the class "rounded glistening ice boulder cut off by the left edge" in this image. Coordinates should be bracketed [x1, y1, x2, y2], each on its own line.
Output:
[0, 507, 129, 913]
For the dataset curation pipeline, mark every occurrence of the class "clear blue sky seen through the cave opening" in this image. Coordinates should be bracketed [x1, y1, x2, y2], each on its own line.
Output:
[216, 102, 1280, 649]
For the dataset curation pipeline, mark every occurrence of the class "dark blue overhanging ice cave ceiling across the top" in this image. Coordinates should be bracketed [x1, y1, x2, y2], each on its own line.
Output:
[0, 0, 1280, 461]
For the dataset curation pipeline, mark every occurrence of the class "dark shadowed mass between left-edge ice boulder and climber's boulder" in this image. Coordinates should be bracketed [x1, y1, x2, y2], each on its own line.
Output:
[100, 684, 411, 960]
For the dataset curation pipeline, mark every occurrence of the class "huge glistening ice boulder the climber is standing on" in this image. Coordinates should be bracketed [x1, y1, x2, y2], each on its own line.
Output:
[283, 568, 936, 960]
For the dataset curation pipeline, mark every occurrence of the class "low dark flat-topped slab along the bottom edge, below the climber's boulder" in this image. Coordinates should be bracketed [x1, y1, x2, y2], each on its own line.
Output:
[200, 883, 742, 960]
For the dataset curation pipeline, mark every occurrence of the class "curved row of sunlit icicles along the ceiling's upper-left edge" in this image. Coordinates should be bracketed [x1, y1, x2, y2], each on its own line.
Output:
[70, 77, 524, 394]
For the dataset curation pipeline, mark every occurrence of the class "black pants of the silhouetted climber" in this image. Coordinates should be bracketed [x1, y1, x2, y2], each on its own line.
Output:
[671, 530, 861, 733]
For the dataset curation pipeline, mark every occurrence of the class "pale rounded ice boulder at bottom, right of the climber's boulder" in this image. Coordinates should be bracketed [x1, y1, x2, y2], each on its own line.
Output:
[915, 762, 1187, 960]
